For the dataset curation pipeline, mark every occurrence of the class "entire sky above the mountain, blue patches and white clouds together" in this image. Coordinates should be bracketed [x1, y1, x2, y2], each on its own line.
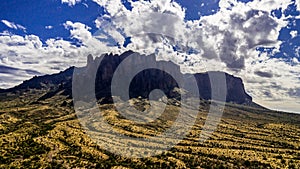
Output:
[0, 0, 300, 112]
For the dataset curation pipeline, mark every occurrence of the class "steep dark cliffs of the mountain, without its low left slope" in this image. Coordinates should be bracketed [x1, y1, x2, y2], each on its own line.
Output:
[74, 51, 252, 104]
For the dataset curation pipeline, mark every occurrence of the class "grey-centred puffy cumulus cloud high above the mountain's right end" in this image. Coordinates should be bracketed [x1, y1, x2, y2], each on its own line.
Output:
[201, 0, 290, 69]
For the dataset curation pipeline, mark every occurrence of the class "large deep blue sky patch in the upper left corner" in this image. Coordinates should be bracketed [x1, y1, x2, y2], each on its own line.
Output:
[0, 0, 104, 41]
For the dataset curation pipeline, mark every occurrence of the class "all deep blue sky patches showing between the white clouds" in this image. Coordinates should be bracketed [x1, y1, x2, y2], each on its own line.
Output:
[0, 0, 300, 61]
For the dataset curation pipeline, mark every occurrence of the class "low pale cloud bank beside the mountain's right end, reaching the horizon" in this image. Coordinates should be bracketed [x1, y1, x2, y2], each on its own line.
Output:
[236, 55, 300, 112]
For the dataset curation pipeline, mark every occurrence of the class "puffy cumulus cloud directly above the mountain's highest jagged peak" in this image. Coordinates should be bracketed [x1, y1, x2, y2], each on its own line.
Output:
[95, 0, 185, 58]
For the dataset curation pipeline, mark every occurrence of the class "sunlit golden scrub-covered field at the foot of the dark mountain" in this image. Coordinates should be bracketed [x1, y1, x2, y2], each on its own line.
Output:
[0, 91, 300, 168]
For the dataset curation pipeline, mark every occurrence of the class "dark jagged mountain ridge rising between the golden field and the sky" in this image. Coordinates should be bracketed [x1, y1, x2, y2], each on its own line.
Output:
[0, 51, 254, 105]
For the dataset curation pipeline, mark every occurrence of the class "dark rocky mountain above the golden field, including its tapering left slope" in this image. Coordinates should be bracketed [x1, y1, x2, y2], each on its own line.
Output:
[4, 51, 252, 104]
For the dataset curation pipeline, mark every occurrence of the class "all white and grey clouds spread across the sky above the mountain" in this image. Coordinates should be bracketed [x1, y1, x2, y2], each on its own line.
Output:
[0, 0, 300, 113]
